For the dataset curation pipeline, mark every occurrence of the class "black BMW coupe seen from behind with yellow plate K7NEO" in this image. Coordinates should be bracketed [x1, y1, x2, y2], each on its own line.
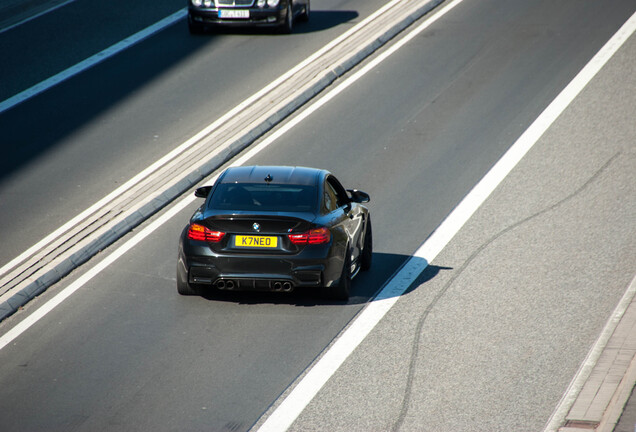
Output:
[177, 166, 373, 300]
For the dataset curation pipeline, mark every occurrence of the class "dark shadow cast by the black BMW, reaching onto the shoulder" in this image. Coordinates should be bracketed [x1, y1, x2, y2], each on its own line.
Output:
[202, 253, 452, 307]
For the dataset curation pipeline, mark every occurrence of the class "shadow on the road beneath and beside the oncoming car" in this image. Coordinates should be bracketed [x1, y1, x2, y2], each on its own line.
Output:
[193, 10, 360, 38]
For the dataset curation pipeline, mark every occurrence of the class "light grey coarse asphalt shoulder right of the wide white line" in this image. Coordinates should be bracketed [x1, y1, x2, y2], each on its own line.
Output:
[264, 13, 636, 431]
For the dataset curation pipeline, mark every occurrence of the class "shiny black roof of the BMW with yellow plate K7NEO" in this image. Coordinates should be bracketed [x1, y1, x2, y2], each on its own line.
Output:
[219, 165, 328, 186]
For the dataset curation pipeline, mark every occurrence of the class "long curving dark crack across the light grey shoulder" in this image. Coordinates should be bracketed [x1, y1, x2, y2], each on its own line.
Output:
[391, 151, 621, 432]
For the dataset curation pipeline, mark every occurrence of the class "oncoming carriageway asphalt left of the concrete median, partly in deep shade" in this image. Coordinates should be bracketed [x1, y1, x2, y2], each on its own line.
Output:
[0, 0, 382, 264]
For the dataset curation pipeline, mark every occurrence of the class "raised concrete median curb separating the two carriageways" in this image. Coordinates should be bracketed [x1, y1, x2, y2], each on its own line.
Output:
[0, 0, 443, 320]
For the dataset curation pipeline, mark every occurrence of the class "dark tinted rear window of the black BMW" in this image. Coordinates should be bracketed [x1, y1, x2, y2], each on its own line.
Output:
[210, 183, 317, 212]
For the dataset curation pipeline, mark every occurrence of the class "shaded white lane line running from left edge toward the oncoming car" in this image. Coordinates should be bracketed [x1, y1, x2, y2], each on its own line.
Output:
[0, 8, 187, 114]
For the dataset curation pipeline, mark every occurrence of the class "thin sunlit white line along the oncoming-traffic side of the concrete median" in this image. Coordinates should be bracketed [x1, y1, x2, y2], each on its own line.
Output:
[0, 0, 422, 277]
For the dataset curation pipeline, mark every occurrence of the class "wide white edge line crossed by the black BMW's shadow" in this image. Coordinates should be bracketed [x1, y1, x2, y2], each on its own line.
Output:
[253, 7, 636, 432]
